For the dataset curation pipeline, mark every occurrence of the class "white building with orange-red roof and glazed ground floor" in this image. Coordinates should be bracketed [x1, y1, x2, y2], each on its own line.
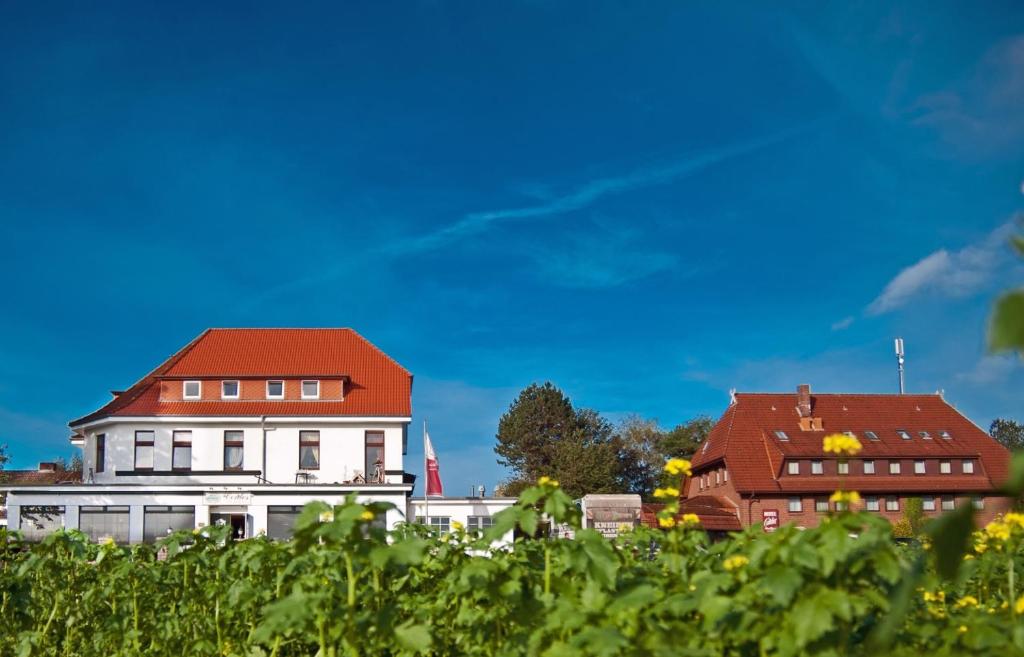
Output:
[5, 329, 419, 542]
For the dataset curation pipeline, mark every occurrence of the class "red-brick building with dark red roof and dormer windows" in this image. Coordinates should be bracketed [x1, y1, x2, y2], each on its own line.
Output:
[682, 385, 1010, 527]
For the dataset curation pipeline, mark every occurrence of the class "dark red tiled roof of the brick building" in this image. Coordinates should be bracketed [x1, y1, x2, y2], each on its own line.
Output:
[692, 393, 1010, 493]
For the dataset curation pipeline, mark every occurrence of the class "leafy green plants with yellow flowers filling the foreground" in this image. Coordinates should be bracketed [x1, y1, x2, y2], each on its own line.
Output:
[0, 480, 1024, 657]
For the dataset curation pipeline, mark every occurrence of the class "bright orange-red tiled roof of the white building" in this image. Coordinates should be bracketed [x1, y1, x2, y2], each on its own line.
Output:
[71, 329, 413, 427]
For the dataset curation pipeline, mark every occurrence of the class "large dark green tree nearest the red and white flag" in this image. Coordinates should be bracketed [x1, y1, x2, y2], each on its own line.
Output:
[495, 382, 622, 497]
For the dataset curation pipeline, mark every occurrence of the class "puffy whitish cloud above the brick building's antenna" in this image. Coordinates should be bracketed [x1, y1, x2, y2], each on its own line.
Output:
[866, 221, 1014, 315]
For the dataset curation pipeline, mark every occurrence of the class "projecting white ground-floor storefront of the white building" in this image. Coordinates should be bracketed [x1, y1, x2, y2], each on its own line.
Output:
[7, 484, 412, 543]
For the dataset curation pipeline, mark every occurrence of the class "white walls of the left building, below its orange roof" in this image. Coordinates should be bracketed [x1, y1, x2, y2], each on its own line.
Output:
[6, 417, 413, 542]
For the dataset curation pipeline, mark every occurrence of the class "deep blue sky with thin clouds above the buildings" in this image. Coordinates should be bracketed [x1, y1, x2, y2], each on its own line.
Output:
[0, 2, 1024, 492]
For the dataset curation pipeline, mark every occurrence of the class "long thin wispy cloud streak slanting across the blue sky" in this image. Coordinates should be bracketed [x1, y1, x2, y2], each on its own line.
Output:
[388, 121, 818, 254]
